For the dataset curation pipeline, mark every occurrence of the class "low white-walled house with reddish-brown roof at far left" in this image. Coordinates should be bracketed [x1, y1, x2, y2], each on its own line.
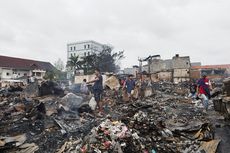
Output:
[0, 56, 56, 81]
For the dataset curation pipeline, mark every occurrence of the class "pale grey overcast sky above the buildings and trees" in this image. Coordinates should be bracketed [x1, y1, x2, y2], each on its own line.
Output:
[0, 0, 230, 67]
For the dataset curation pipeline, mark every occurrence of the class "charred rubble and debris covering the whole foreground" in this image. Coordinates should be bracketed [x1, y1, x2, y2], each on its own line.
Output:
[0, 78, 229, 153]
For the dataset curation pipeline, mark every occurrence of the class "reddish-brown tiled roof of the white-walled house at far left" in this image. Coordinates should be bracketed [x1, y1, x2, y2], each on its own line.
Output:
[0, 55, 55, 71]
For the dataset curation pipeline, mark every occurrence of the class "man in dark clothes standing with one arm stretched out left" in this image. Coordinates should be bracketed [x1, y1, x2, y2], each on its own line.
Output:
[87, 69, 103, 113]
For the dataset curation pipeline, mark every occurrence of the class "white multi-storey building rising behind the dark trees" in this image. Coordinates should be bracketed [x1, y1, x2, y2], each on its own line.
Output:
[67, 40, 106, 60]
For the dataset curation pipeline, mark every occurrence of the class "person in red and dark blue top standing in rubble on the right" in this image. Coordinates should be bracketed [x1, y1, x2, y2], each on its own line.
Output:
[197, 73, 211, 112]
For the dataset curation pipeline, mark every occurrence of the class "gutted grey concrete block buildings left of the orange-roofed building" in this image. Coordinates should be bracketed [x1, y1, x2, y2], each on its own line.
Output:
[124, 54, 191, 83]
